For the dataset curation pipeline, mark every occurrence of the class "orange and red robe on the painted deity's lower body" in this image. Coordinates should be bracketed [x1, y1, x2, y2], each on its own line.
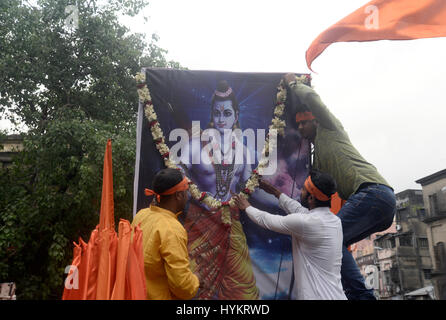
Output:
[184, 202, 259, 300]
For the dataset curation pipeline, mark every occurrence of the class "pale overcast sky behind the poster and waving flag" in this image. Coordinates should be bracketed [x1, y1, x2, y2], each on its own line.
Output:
[3, 0, 446, 192]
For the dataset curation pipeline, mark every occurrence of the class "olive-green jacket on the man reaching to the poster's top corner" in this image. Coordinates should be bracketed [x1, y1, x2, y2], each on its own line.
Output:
[290, 82, 390, 199]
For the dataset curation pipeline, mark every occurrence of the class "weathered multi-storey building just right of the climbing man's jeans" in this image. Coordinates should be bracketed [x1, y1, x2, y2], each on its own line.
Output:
[353, 189, 432, 300]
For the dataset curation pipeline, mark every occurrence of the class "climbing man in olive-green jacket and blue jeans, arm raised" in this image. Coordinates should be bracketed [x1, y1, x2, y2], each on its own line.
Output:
[284, 74, 396, 300]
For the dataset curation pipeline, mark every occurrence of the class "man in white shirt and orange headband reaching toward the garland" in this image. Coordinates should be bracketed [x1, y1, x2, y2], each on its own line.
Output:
[234, 171, 347, 300]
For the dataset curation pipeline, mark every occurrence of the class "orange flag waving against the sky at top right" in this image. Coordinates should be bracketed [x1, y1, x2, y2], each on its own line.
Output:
[306, 0, 446, 71]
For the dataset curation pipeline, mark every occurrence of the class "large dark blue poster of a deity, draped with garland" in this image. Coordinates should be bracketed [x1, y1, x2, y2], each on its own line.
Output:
[133, 68, 310, 300]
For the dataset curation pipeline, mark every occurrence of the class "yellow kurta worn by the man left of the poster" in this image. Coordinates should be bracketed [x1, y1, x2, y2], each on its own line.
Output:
[132, 205, 199, 300]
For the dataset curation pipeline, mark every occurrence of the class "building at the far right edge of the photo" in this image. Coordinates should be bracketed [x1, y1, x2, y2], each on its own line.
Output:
[416, 169, 446, 300]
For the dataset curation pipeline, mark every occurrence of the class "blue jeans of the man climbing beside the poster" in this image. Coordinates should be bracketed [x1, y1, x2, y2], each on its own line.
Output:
[337, 184, 396, 300]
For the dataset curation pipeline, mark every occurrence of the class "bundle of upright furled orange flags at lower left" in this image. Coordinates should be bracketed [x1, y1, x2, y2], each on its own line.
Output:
[62, 140, 146, 300]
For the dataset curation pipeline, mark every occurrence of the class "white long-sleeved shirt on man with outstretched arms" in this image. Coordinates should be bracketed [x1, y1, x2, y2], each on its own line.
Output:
[246, 193, 347, 300]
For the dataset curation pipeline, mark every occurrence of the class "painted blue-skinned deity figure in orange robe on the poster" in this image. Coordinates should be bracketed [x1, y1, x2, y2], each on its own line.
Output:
[181, 81, 259, 300]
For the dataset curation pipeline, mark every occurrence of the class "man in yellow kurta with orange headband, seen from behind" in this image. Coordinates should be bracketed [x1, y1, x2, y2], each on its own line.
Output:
[132, 169, 199, 300]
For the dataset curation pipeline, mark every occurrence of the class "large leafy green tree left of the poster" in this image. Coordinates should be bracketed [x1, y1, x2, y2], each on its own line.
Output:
[0, 0, 180, 299]
